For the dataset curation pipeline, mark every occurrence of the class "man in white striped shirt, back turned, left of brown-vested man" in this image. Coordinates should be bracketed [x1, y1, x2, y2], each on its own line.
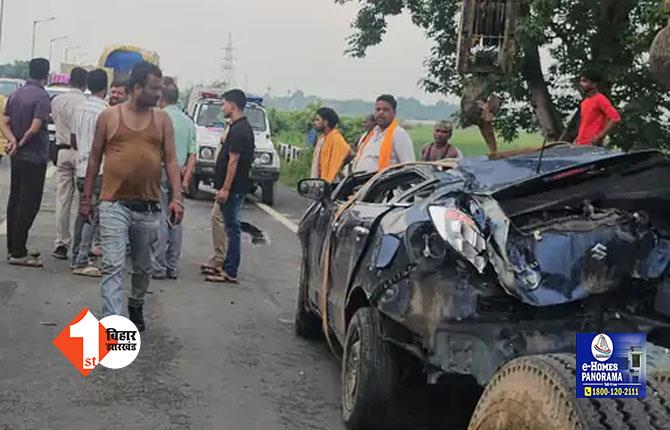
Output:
[71, 69, 108, 278]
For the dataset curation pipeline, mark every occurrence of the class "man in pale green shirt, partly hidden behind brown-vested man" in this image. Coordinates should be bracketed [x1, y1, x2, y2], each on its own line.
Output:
[153, 80, 198, 279]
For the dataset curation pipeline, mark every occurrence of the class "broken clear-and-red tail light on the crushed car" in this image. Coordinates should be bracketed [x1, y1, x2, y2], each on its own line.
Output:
[428, 206, 486, 273]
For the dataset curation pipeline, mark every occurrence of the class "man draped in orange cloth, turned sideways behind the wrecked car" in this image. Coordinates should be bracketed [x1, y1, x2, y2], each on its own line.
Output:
[311, 107, 353, 182]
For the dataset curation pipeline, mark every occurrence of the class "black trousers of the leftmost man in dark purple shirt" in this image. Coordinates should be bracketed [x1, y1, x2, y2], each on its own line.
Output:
[7, 157, 47, 258]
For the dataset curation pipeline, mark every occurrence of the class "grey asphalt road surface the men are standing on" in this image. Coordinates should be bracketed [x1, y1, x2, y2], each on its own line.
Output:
[0, 160, 478, 430]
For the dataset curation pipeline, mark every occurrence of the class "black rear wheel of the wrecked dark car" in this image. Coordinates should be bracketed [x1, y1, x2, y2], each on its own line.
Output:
[342, 308, 399, 430]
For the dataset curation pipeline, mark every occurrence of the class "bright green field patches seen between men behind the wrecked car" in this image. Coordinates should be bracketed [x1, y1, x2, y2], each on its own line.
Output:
[407, 126, 542, 157]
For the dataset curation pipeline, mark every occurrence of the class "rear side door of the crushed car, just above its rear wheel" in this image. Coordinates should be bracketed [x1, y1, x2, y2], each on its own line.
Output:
[328, 171, 425, 336]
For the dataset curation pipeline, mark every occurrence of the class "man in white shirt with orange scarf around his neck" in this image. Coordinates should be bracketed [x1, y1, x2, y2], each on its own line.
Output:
[354, 95, 416, 173]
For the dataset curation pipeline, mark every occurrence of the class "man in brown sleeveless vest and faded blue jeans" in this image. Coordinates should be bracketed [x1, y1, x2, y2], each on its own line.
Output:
[79, 62, 184, 331]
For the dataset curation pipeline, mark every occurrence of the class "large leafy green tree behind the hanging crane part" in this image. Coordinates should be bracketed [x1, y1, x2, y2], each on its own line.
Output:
[335, 0, 670, 149]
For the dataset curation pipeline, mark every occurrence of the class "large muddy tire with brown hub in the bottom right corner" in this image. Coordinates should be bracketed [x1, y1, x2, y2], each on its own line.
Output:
[468, 354, 670, 430]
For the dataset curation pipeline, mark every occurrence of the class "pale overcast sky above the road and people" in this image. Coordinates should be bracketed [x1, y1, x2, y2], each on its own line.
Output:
[0, 0, 446, 102]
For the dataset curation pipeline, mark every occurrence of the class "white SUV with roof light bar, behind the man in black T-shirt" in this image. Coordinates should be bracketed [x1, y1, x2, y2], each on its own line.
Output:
[186, 89, 280, 206]
